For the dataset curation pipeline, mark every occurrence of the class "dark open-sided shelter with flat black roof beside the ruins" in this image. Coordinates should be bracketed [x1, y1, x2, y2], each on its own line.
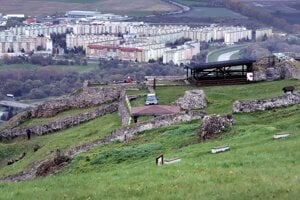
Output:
[185, 59, 256, 85]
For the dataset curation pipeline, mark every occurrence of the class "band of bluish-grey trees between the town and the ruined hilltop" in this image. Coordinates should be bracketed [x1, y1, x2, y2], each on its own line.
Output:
[0, 60, 185, 99]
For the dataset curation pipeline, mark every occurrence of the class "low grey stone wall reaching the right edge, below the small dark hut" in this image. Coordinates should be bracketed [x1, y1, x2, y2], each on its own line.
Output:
[232, 92, 300, 113]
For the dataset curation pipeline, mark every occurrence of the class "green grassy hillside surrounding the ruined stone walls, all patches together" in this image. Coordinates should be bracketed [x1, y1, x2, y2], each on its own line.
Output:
[0, 80, 300, 199]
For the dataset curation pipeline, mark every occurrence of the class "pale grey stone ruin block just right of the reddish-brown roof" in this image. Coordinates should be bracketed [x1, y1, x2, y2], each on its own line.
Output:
[174, 89, 207, 110]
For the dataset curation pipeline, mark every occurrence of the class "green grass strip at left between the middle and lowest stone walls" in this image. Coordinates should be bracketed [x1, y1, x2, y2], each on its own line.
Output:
[0, 113, 121, 176]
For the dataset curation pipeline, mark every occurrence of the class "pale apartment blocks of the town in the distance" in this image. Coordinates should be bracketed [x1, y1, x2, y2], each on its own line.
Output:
[0, 11, 272, 65]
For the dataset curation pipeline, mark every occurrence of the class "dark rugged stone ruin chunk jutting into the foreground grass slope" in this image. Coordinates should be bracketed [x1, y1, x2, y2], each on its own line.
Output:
[198, 115, 234, 140]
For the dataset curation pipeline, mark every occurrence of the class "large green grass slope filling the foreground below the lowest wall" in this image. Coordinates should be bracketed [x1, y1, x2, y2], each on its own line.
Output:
[0, 106, 300, 199]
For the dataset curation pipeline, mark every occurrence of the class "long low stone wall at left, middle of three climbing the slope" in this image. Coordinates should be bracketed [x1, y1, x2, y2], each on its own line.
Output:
[0, 103, 118, 140]
